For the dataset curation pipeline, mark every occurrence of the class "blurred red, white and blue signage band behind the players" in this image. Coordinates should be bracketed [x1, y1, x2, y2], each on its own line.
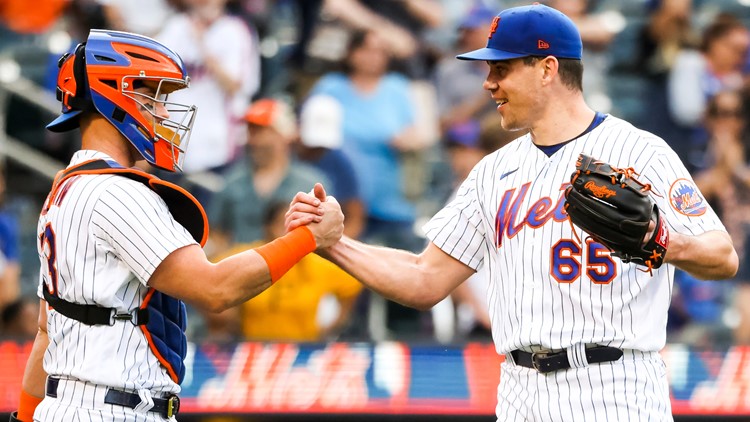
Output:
[0, 342, 750, 415]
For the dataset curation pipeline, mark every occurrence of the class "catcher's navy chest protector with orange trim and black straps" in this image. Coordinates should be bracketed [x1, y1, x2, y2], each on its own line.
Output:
[43, 160, 208, 384]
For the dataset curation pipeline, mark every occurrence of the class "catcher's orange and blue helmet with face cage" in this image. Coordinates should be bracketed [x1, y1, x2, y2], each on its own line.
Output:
[47, 29, 196, 171]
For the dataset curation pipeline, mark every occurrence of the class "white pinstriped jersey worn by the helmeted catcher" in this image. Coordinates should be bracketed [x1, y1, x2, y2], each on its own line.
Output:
[38, 151, 196, 393]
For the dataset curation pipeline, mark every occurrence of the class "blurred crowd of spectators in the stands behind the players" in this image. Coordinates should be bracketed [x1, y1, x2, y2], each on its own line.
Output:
[0, 0, 750, 346]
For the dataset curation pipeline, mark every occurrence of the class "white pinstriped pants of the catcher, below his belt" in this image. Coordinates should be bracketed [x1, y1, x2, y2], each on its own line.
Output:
[34, 379, 175, 422]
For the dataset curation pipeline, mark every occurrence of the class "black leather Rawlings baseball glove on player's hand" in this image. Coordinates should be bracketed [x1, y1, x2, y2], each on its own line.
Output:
[565, 154, 669, 271]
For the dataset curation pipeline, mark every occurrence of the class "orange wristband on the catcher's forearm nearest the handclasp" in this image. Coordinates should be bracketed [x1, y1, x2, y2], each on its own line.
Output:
[255, 226, 317, 283]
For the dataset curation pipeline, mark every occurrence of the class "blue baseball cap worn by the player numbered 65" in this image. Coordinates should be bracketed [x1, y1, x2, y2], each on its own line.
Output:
[456, 3, 583, 61]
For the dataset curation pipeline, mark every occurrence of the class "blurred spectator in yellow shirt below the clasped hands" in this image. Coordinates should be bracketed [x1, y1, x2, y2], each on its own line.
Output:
[205, 203, 362, 342]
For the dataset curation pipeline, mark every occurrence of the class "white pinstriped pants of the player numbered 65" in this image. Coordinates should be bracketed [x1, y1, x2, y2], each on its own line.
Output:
[495, 350, 673, 422]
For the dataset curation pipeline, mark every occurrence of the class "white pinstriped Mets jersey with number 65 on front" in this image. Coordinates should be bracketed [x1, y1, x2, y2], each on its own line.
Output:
[425, 116, 725, 354]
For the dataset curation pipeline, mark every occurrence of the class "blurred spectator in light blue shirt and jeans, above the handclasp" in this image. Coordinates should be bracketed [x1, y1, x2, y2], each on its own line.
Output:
[312, 32, 426, 251]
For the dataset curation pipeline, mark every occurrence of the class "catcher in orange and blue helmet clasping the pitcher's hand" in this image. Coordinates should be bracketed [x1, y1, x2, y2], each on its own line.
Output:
[11, 29, 344, 422]
